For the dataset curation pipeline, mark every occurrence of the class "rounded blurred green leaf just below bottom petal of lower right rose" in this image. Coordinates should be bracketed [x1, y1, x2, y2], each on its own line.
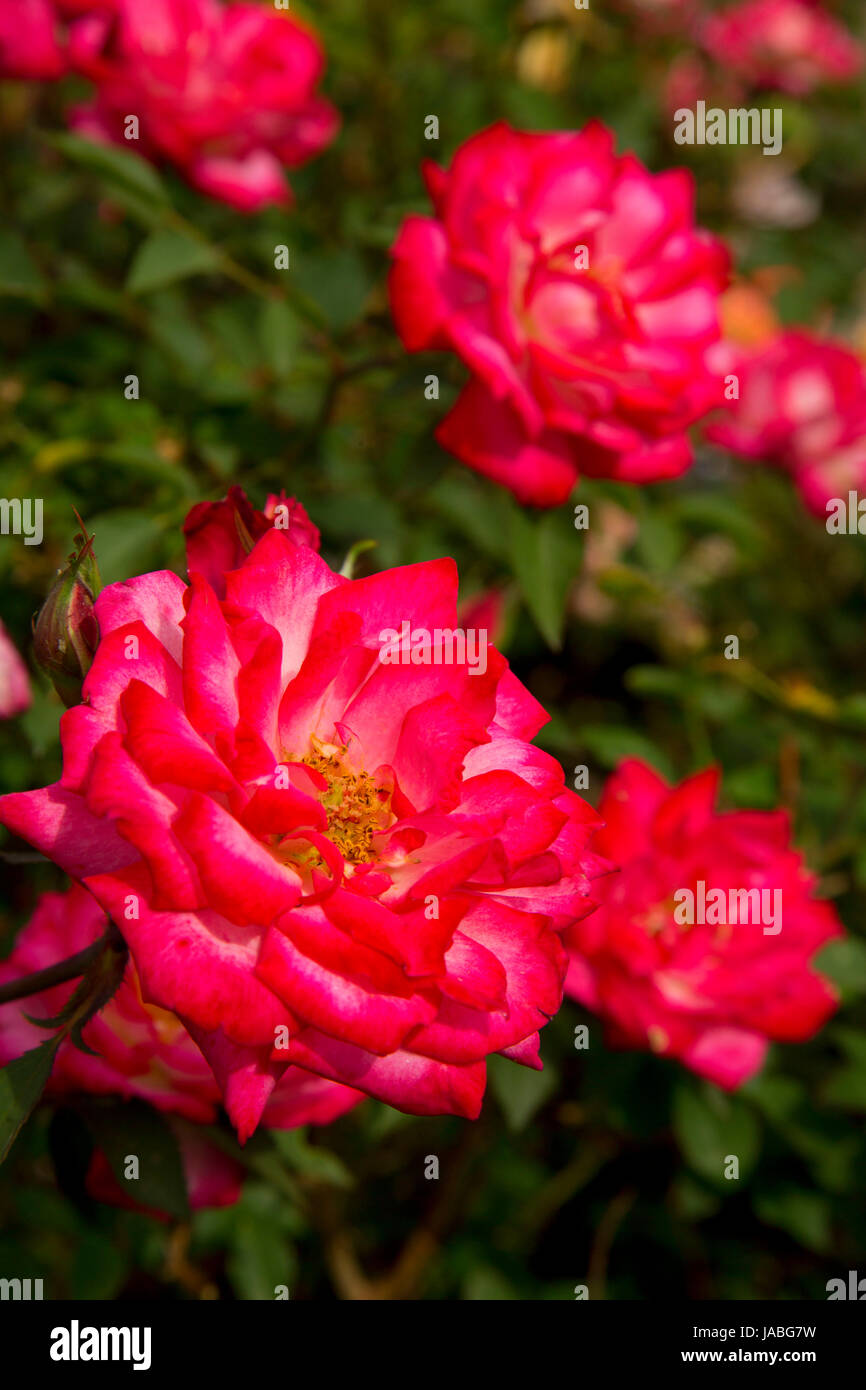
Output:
[673, 1083, 760, 1190]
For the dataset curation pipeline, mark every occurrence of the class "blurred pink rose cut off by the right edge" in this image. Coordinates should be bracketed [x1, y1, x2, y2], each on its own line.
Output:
[706, 329, 866, 517]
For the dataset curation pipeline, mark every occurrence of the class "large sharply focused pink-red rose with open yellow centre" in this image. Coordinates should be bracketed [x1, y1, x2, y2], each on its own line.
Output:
[0, 528, 598, 1137]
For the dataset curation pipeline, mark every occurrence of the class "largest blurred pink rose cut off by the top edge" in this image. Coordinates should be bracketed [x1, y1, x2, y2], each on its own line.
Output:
[70, 0, 339, 213]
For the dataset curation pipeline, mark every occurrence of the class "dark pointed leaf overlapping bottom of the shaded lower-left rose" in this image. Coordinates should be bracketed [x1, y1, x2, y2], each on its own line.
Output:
[81, 1101, 189, 1220]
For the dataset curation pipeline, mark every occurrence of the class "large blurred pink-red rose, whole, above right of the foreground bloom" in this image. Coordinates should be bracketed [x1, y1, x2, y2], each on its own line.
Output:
[391, 122, 728, 506]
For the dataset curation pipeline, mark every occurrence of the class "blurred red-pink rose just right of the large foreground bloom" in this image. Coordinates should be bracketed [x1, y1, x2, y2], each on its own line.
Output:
[566, 759, 841, 1088]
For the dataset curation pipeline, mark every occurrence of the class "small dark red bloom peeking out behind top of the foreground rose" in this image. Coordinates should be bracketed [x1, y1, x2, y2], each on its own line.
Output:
[183, 488, 321, 598]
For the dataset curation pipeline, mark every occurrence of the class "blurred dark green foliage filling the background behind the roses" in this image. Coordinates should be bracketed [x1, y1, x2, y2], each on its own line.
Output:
[0, 0, 866, 1300]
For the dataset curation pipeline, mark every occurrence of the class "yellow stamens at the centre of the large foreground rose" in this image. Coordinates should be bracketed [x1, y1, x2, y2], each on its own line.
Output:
[302, 734, 395, 865]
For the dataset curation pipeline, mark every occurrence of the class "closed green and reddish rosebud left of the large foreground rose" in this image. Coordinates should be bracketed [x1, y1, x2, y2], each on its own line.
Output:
[33, 522, 101, 708]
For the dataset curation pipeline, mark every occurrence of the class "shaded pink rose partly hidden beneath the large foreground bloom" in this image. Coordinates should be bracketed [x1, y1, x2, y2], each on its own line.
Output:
[0, 884, 364, 1207]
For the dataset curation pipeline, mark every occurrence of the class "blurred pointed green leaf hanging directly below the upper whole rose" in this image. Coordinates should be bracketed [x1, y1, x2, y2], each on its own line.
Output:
[509, 507, 581, 651]
